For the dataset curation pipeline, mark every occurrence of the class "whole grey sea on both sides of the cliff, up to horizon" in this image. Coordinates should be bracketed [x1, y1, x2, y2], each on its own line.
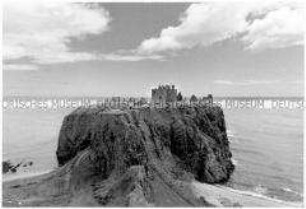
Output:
[3, 97, 304, 203]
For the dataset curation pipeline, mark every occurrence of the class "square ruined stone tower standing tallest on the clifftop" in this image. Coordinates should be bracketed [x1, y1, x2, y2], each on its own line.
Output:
[151, 85, 177, 104]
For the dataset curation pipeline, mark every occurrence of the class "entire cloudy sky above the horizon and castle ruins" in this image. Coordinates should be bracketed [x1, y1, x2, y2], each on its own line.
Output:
[3, 0, 304, 97]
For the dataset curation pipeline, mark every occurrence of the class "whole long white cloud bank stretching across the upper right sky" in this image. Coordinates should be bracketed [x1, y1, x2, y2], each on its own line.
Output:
[137, 0, 303, 54]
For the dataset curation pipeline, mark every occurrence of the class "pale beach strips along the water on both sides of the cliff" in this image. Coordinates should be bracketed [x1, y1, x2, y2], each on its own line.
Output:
[2, 169, 303, 208]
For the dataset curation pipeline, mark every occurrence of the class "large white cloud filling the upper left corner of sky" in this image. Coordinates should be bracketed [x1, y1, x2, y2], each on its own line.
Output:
[3, 1, 110, 64]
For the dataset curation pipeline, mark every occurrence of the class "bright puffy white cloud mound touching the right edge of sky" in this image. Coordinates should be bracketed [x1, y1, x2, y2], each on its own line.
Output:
[243, 6, 304, 50]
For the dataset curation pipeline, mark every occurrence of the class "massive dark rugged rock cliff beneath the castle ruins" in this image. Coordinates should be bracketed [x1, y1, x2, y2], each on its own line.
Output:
[56, 107, 234, 206]
